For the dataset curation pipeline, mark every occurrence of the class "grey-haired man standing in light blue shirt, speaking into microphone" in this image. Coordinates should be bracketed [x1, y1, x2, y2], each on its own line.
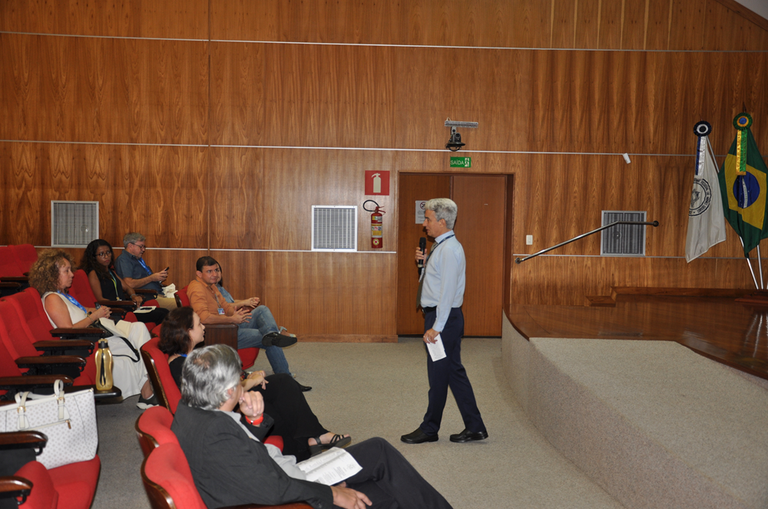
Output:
[400, 198, 488, 444]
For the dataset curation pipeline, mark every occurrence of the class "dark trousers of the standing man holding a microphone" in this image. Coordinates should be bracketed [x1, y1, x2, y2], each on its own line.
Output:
[421, 308, 487, 435]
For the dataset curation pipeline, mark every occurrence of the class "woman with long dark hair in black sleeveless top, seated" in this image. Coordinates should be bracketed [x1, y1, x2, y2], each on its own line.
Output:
[80, 239, 168, 325]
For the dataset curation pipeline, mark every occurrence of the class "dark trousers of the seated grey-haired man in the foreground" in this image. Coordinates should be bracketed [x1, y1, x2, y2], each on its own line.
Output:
[346, 438, 451, 509]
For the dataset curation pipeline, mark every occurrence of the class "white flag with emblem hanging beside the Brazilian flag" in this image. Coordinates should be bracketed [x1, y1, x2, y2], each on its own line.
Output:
[685, 122, 725, 263]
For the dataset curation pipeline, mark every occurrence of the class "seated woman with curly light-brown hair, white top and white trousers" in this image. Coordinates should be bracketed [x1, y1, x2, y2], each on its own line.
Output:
[29, 249, 156, 408]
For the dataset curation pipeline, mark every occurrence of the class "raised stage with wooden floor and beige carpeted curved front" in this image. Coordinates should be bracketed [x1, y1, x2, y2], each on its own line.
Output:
[502, 296, 768, 509]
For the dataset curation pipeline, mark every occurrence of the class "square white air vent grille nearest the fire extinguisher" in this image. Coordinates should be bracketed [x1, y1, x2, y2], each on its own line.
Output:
[312, 205, 357, 251]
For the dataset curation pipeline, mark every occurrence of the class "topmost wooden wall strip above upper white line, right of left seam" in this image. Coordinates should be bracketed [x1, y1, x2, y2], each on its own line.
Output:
[206, 0, 768, 51]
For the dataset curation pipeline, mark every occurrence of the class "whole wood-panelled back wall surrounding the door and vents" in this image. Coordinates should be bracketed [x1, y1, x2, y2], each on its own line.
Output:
[0, 0, 768, 337]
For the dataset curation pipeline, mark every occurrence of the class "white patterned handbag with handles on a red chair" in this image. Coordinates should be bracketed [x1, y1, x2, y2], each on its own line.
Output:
[0, 380, 99, 469]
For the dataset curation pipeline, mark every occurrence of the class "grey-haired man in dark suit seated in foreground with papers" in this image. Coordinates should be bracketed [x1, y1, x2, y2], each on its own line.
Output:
[171, 342, 451, 509]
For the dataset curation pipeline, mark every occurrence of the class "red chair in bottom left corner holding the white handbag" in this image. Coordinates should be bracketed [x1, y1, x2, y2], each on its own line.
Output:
[0, 431, 101, 509]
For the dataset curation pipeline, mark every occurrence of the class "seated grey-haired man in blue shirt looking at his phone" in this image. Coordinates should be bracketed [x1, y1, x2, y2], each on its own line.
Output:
[115, 232, 176, 310]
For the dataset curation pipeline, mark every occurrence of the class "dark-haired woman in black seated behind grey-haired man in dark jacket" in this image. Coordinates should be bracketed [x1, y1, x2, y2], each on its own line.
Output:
[158, 307, 351, 461]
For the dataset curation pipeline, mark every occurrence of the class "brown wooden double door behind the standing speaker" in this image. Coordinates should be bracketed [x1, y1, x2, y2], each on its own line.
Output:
[397, 173, 512, 336]
